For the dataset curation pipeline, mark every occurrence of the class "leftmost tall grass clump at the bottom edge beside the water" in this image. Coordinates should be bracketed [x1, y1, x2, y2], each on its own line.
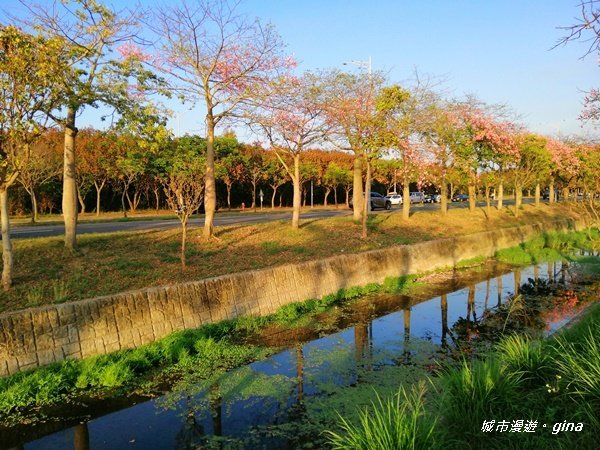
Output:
[328, 383, 436, 450]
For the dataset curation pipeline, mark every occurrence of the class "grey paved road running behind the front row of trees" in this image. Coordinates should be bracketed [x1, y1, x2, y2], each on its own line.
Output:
[10, 199, 532, 239]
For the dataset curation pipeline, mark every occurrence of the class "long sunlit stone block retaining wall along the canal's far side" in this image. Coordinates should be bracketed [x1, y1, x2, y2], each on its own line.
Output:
[0, 220, 582, 376]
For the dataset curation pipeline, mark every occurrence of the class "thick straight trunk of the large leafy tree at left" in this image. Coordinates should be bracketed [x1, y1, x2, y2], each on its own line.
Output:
[62, 106, 77, 250]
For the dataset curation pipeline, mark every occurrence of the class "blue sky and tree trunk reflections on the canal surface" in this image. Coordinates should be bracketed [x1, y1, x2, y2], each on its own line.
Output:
[16, 264, 596, 450]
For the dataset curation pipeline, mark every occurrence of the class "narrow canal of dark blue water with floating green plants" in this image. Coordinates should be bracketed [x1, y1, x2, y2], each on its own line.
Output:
[0, 256, 596, 450]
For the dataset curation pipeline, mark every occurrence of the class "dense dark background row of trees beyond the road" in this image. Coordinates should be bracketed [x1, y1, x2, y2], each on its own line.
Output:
[17, 129, 600, 222]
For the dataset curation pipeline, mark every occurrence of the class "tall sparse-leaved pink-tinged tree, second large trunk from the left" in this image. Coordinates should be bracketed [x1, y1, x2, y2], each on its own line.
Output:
[150, 0, 295, 238]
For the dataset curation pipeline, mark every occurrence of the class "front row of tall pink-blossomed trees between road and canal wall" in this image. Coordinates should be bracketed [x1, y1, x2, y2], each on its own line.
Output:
[0, 0, 597, 288]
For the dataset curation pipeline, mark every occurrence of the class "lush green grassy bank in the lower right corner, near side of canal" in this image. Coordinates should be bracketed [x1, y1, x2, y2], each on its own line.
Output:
[329, 288, 600, 450]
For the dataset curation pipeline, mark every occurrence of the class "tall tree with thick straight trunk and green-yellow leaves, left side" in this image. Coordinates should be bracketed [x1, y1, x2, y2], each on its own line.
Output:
[27, 0, 152, 250]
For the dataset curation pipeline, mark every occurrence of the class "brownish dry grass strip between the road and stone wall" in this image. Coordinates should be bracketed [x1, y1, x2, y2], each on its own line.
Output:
[0, 205, 579, 312]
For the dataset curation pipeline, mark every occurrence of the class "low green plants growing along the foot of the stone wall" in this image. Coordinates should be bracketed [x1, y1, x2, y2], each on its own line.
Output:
[0, 230, 600, 423]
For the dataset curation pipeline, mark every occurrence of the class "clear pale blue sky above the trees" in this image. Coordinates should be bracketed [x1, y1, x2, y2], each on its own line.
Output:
[2, 0, 600, 141]
